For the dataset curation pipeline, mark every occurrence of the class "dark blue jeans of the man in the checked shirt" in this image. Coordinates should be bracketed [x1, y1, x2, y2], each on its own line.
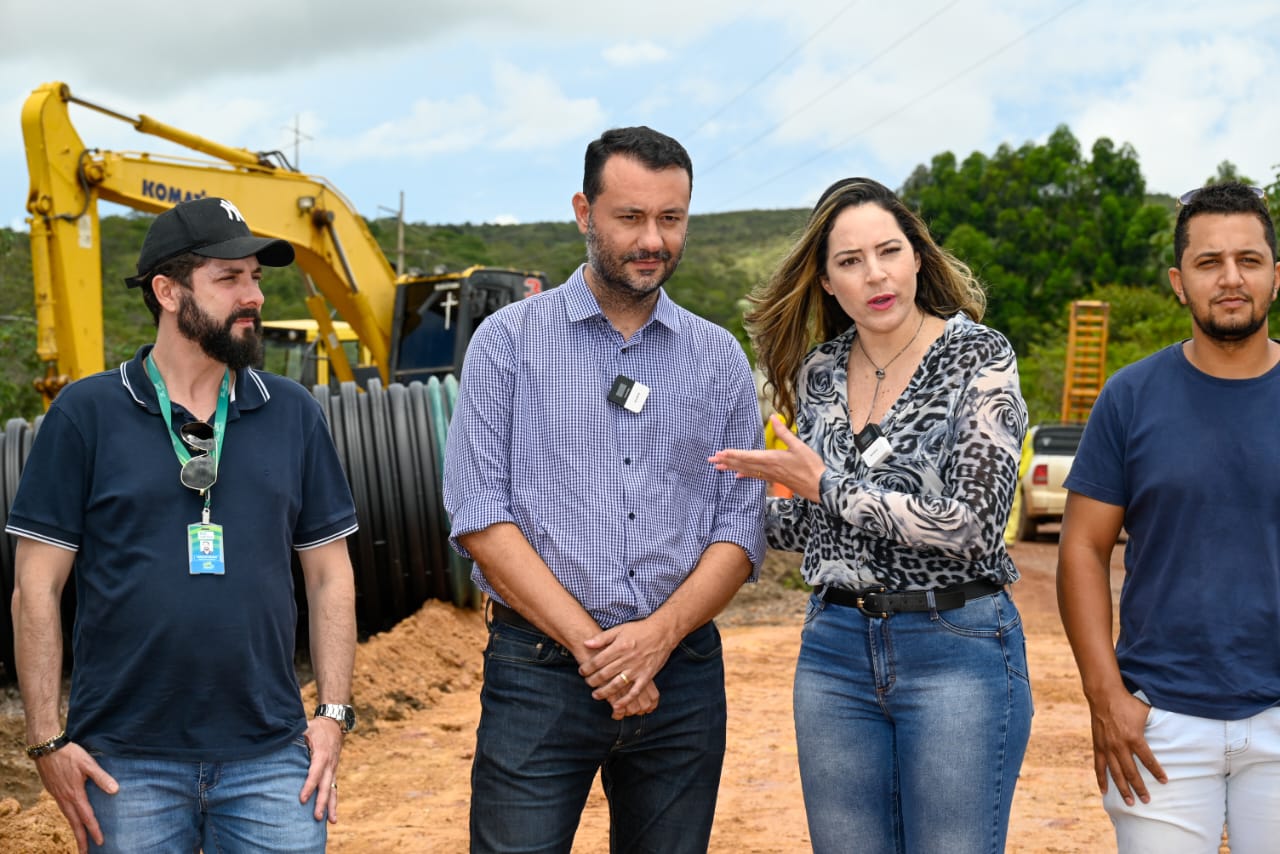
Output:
[471, 622, 726, 854]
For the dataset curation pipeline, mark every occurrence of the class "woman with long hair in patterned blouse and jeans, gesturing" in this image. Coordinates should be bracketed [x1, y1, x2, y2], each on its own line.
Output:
[712, 178, 1032, 854]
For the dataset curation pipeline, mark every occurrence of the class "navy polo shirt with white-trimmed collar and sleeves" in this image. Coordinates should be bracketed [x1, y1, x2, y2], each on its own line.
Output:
[5, 344, 356, 762]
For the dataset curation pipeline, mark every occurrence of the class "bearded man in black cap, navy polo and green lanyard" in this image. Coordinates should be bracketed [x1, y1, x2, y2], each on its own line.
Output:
[6, 198, 356, 851]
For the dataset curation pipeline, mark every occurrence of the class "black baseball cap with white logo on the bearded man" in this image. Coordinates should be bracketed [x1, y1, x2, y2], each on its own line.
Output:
[124, 196, 293, 288]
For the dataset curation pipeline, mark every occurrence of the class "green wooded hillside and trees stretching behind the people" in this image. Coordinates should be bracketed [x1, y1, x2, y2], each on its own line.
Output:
[0, 127, 1277, 419]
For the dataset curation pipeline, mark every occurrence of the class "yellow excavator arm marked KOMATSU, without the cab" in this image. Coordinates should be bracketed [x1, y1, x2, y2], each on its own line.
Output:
[22, 83, 396, 403]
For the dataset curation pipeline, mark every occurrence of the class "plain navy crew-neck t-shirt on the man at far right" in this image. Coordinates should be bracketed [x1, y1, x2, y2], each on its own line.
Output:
[1066, 344, 1280, 721]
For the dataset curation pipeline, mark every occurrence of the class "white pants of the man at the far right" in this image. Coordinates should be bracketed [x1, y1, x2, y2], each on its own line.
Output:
[1102, 691, 1280, 854]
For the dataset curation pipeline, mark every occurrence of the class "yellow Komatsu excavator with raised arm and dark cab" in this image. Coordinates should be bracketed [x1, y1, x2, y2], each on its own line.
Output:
[22, 82, 547, 406]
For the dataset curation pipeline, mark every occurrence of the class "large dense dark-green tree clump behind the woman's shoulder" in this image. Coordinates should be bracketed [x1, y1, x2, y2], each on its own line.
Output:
[901, 125, 1169, 353]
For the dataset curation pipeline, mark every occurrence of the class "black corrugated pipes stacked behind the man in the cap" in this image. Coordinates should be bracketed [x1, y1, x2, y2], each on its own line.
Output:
[0, 374, 481, 681]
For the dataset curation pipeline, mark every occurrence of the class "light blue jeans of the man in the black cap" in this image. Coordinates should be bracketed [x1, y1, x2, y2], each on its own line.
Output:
[86, 736, 328, 854]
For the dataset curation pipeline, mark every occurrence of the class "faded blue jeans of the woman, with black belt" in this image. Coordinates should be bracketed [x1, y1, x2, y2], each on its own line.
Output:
[795, 592, 1032, 854]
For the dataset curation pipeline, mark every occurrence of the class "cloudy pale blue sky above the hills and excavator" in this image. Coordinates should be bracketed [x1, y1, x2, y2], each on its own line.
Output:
[0, 0, 1280, 227]
